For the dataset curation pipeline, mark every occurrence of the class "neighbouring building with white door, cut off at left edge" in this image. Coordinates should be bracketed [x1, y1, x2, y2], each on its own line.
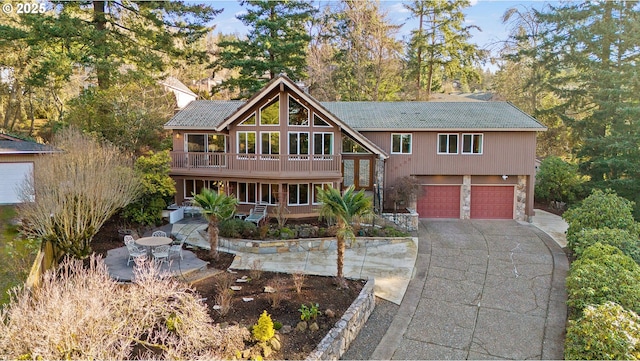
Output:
[0, 133, 55, 204]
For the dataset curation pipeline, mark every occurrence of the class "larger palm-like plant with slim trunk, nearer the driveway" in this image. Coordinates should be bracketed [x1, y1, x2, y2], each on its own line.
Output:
[317, 186, 373, 283]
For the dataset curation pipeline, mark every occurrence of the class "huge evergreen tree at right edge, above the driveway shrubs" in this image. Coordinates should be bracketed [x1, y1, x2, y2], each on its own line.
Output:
[540, 1, 640, 212]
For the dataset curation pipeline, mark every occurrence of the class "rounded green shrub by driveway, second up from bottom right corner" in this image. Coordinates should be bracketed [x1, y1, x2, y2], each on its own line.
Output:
[567, 243, 640, 319]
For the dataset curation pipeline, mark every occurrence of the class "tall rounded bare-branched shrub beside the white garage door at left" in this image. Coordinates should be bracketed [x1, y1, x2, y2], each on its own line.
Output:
[18, 129, 140, 258]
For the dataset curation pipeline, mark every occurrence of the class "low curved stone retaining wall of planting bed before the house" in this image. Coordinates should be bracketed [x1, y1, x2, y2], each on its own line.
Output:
[218, 237, 412, 254]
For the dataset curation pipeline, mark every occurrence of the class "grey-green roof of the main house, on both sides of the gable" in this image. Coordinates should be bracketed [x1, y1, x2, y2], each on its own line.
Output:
[165, 100, 546, 131]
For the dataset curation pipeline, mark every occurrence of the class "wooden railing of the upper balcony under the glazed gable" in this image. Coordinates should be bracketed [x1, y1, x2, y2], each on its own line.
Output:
[171, 152, 341, 173]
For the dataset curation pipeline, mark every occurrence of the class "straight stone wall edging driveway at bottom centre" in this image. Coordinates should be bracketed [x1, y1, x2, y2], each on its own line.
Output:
[306, 279, 375, 361]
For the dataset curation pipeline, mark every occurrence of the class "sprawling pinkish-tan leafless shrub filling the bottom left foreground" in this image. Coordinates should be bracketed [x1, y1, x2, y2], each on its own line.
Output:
[0, 258, 250, 360]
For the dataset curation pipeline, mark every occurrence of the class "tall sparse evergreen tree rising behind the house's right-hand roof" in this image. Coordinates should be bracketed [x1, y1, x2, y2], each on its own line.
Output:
[405, 0, 485, 100]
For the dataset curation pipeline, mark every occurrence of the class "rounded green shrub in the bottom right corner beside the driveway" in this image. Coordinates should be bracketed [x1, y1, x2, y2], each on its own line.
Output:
[564, 302, 640, 360]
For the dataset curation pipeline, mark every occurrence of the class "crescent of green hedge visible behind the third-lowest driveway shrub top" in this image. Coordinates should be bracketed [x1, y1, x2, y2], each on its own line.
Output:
[567, 227, 640, 264]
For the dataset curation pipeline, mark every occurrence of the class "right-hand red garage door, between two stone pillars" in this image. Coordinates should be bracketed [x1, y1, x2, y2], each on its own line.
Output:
[471, 186, 513, 219]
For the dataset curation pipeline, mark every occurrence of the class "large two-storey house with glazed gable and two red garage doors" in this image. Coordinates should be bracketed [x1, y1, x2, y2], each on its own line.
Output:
[165, 76, 546, 220]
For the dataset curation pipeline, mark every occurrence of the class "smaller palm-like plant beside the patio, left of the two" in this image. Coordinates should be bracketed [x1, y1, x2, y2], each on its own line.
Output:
[193, 188, 238, 258]
